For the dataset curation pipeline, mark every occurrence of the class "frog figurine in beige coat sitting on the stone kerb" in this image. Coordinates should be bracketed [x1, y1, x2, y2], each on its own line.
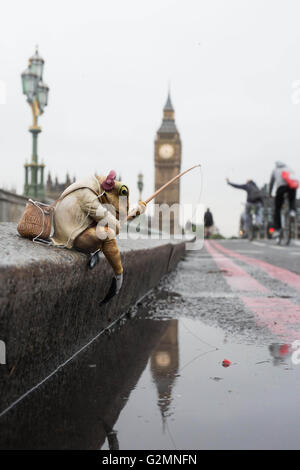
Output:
[52, 171, 146, 302]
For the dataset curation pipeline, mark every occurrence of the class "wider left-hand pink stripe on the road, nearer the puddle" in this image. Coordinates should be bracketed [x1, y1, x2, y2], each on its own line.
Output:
[205, 241, 300, 341]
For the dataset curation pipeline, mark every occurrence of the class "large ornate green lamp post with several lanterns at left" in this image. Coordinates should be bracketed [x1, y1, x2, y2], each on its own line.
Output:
[21, 48, 49, 199]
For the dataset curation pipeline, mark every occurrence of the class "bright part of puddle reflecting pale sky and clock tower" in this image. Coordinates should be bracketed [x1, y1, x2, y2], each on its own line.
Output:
[102, 318, 300, 449]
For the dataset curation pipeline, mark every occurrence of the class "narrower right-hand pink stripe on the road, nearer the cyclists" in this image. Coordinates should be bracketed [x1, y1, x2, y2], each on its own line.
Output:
[211, 242, 300, 290]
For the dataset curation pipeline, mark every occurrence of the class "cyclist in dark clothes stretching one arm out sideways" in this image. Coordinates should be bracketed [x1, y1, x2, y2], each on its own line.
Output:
[226, 178, 263, 232]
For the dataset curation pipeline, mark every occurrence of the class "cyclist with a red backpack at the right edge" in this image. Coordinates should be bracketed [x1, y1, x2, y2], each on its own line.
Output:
[269, 161, 299, 238]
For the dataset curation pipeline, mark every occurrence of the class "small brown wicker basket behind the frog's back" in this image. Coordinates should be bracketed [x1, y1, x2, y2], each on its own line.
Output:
[17, 199, 54, 240]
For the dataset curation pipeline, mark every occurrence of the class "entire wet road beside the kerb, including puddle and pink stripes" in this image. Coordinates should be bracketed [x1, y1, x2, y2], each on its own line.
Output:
[0, 241, 300, 449]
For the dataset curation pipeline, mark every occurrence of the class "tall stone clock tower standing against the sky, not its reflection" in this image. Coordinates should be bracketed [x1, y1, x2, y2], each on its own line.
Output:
[154, 93, 181, 233]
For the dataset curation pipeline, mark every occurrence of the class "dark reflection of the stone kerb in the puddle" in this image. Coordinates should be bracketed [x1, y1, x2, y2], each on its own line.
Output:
[0, 318, 176, 449]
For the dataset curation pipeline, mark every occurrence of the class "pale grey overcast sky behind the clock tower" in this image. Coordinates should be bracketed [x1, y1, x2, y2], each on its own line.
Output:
[0, 0, 300, 236]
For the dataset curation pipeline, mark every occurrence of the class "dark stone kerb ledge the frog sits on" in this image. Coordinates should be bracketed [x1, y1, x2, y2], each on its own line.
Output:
[0, 223, 185, 413]
